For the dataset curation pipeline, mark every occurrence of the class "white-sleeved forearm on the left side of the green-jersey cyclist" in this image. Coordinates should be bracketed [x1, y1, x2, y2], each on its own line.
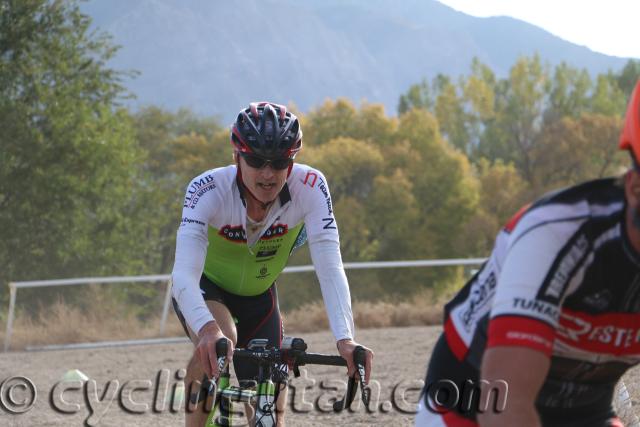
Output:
[171, 232, 213, 333]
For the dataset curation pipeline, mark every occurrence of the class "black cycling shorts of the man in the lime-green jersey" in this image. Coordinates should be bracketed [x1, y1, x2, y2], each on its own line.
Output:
[173, 274, 284, 381]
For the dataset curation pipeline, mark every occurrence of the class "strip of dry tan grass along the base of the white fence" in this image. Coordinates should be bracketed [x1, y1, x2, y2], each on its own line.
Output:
[0, 291, 446, 350]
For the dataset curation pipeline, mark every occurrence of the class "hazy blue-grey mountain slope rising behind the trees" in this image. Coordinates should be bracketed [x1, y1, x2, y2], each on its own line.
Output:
[82, 0, 626, 122]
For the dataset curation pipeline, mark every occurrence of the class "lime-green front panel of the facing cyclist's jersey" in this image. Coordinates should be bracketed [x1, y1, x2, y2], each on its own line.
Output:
[204, 223, 305, 296]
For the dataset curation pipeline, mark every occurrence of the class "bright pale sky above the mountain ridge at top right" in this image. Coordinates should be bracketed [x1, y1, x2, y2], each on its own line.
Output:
[438, 0, 640, 59]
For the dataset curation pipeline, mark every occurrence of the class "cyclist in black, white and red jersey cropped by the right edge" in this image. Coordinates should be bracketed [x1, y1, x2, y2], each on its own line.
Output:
[415, 82, 640, 427]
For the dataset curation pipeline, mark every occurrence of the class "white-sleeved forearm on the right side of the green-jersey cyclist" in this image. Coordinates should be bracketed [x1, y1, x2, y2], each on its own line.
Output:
[309, 240, 355, 341]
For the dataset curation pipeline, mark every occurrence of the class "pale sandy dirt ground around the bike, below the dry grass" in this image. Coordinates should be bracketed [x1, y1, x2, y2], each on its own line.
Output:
[0, 327, 640, 427]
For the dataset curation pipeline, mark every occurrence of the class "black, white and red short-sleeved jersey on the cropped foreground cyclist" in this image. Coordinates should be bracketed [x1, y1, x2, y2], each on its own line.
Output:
[430, 179, 640, 422]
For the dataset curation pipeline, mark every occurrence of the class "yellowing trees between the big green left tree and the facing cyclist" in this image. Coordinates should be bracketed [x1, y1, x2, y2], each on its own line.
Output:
[133, 107, 226, 273]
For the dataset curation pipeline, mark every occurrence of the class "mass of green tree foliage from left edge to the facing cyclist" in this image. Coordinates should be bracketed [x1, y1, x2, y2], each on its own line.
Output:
[0, 0, 230, 314]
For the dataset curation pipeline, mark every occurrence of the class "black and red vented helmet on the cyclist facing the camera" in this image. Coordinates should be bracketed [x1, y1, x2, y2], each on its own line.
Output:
[231, 102, 302, 160]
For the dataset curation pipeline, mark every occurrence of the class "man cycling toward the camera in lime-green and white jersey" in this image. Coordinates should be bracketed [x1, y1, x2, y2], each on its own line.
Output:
[172, 102, 373, 426]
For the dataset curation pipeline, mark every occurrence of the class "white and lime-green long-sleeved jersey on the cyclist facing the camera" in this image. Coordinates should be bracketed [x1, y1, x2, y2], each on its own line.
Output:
[172, 164, 354, 340]
